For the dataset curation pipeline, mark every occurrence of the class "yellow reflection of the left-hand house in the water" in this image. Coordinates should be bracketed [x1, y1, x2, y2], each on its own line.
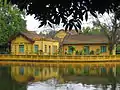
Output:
[11, 66, 59, 82]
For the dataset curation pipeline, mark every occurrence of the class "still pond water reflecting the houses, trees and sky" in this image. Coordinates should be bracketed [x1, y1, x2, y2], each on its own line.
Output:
[0, 63, 120, 90]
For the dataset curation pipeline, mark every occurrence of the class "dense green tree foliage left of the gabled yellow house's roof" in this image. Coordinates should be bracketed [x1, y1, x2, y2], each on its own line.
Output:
[0, 3, 26, 44]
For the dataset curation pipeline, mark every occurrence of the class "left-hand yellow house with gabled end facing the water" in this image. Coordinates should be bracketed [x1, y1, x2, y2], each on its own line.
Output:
[10, 31, 59, 55]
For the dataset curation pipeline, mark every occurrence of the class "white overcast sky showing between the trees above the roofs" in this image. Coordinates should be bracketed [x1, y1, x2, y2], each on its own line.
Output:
[25, 13, 108, 33]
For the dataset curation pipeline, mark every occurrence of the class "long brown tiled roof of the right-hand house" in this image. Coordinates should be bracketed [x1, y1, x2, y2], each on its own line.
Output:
[63, 34, 108, 44]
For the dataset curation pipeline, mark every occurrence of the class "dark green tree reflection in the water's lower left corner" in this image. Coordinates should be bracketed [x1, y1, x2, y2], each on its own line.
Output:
[0, 66, 27, 90]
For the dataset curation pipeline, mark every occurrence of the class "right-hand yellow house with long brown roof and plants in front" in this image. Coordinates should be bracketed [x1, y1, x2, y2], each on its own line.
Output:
[62, 34, 115, 55]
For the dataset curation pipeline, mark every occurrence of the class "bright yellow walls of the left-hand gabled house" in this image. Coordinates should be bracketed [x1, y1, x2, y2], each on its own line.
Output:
[11, 36, 59, 55]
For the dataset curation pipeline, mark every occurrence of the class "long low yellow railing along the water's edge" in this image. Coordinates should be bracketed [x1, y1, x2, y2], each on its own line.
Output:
[0, 55, 120, 62]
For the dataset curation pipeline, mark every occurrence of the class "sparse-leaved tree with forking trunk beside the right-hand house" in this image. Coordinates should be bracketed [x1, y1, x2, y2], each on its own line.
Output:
[93, 12, 120, 54]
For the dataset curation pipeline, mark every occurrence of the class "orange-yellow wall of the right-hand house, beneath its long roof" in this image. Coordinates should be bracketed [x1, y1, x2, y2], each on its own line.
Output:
[63, 44, 109, 55]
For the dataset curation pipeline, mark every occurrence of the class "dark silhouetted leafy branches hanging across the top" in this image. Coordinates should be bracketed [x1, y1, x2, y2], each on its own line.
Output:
[2, 0, 120, 31]
